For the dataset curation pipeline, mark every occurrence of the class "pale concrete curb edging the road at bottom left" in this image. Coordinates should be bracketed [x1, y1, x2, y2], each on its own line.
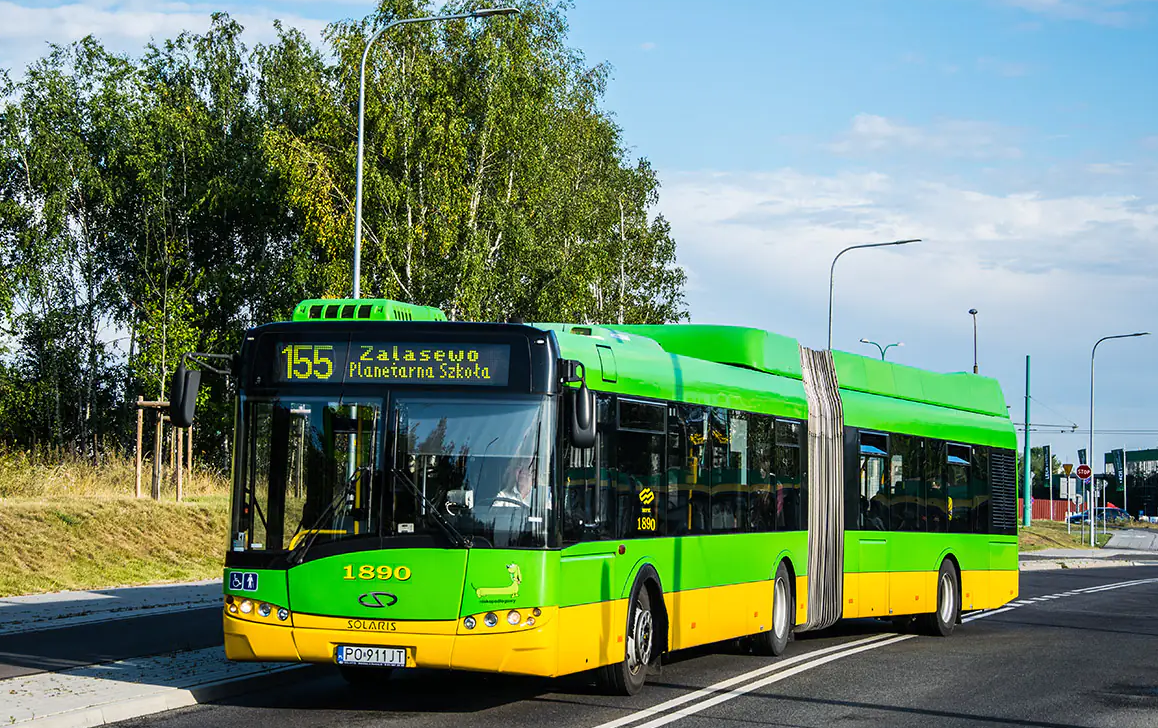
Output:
[13, 664, 310, 728]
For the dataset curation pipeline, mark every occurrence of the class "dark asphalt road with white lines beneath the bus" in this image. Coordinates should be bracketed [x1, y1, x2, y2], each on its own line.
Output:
[110, 567, 1158, 728]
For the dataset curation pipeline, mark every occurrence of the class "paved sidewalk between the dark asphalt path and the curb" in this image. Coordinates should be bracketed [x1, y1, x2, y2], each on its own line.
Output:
[0, 647, 301, 728]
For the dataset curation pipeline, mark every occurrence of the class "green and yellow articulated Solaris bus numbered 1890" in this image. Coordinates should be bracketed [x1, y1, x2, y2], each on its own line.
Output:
[187, 299, 1018, 694]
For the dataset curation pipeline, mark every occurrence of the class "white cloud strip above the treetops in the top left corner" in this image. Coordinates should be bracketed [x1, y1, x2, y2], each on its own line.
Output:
[0, 0, 325, 76]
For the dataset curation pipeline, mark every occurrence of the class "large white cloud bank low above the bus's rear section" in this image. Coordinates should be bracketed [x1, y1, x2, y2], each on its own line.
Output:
[661, 169, 1158, 456]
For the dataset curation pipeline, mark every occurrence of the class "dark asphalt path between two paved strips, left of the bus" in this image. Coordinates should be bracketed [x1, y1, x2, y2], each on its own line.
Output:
[0, 604, 223, 681]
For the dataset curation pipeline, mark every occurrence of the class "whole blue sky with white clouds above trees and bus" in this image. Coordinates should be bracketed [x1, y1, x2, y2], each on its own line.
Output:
[0, 0, 1158, 472]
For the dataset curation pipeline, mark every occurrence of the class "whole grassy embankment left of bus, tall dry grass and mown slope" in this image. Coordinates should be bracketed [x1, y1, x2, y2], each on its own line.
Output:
[0, 450, 229, 597]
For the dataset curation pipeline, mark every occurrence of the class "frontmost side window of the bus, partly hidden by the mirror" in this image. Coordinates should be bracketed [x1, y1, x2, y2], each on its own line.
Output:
[563, 395, 615, 544]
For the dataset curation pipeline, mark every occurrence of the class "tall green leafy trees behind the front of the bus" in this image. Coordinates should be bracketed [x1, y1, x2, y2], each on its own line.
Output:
[0, 0, 686, 463]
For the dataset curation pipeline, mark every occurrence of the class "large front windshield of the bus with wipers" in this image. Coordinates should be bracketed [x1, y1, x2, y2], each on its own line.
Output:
[233, 391, 555, 557]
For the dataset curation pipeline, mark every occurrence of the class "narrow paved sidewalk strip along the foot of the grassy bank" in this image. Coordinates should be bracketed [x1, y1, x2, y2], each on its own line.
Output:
[0, 579, 221, 634]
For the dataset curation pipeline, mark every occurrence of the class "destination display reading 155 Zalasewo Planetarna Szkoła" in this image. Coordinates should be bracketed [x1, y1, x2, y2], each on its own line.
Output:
[274, 341, 511, 387]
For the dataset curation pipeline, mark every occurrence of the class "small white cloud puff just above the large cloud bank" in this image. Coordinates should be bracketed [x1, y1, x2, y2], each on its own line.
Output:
[827, 113, 1021, 159]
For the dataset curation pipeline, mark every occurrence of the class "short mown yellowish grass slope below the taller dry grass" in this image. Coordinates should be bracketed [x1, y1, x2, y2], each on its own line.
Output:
[0, 495, 229, 596]
